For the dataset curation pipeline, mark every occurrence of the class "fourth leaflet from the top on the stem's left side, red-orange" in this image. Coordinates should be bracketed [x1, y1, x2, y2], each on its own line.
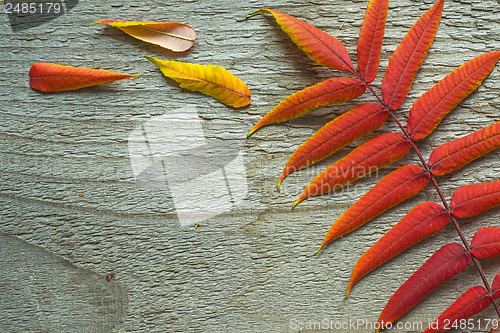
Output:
[293, 133, 411, 207]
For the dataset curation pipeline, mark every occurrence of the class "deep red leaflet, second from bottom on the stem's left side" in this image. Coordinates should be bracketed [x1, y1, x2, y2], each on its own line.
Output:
[377, 243, 471, 332]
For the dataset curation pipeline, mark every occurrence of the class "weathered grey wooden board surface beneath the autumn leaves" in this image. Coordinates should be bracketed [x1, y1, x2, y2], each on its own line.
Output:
[0, 0, 500, 332]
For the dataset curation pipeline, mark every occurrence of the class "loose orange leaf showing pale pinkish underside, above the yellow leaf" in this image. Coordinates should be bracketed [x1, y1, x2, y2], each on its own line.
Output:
[91, 20, 197, 52]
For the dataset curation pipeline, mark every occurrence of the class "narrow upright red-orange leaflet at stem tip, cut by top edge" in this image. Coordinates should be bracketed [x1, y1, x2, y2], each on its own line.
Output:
[358, 0, 389, 83]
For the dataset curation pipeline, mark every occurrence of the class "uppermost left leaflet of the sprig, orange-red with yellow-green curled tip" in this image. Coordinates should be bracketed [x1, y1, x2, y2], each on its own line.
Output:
[247, 8, 356, 75]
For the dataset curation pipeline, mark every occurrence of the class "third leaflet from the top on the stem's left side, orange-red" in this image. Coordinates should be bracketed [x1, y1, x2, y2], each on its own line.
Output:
[278, 103, 389, 190]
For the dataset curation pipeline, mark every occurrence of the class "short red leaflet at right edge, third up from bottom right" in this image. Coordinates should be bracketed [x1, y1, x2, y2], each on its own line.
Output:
[450, 180, 500, 218]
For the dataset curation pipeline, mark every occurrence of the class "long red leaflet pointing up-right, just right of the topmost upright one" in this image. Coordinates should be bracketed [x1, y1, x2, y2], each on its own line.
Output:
[382, 0, 444, 110]
